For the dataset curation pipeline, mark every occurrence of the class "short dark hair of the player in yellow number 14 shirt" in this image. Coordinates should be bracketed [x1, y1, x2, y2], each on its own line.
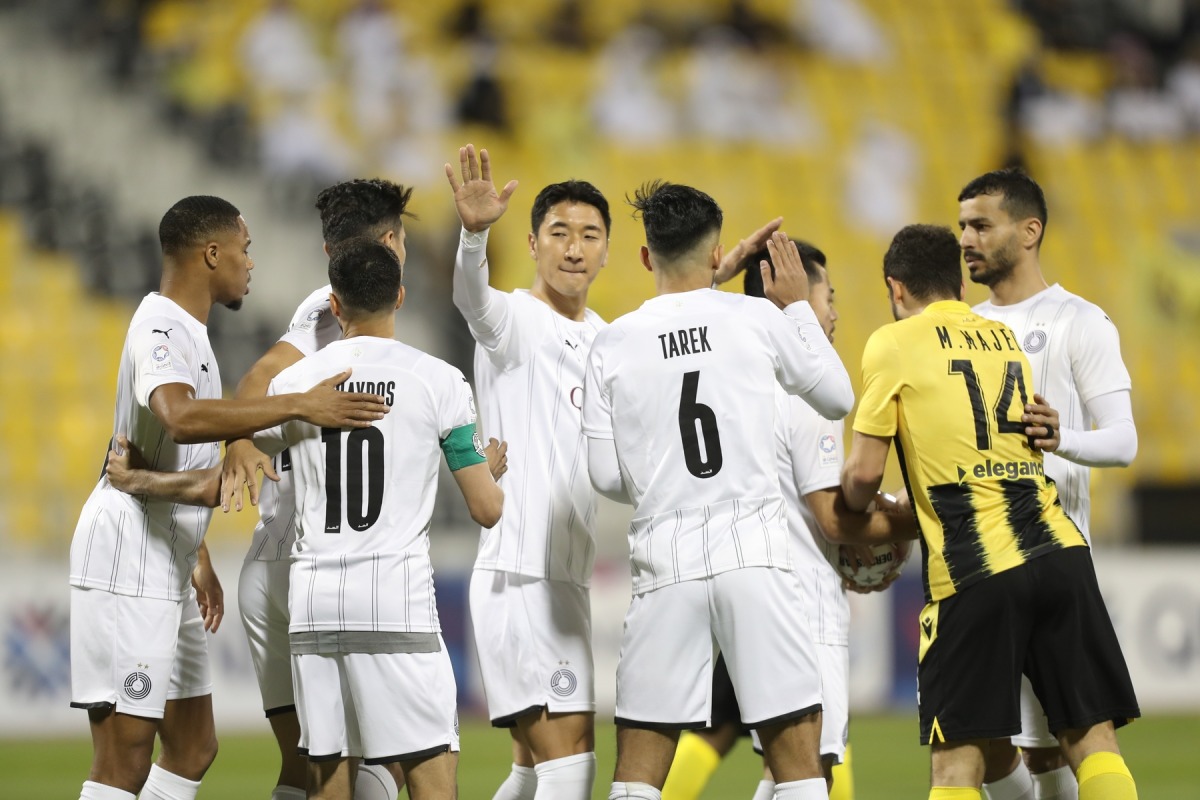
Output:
[883, 225, 962, 302]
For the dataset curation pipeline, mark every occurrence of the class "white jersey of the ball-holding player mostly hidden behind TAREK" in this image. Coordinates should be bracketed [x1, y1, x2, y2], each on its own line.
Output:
[775, 389, 850, 645]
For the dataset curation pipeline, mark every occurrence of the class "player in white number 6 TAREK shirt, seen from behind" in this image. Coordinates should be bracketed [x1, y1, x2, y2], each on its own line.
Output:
[583, 182, 853, 800]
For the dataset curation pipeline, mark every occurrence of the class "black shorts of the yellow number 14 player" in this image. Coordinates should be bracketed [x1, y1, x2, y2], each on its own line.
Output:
[917, 547, 1140, 745]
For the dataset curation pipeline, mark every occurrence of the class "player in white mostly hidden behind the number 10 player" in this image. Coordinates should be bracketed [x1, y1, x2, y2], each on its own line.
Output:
[222, 179, 432, 800]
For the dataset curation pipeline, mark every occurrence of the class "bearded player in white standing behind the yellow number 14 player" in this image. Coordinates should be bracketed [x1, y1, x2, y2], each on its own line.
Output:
[959, 169, 1138, 800]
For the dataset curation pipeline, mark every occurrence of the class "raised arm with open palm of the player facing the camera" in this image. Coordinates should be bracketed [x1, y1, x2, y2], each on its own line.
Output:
[445, 144, 517, 349]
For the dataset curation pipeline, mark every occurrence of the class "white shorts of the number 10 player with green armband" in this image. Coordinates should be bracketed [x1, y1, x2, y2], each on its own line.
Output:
[292, 636, 458, 764]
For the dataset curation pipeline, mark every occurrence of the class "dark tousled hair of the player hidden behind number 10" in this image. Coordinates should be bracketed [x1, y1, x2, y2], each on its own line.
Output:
[317, 178, 415, 248]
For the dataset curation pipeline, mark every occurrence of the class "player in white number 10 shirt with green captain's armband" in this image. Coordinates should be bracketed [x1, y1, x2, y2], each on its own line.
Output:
[254, 237, 504, 800]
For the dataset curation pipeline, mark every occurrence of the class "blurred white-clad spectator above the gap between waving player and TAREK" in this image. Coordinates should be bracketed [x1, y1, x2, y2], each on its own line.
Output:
[592, 25, 679, 144]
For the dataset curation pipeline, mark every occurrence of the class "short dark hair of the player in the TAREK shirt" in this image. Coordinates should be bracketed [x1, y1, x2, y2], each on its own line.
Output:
[625, 180, 725, 260]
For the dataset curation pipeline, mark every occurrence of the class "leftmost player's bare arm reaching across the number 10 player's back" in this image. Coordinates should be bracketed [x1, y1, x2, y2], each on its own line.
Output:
[150, 369, 388, 444]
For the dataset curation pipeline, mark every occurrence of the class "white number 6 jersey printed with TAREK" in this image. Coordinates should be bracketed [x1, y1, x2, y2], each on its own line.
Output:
[583, 289, 852, 594]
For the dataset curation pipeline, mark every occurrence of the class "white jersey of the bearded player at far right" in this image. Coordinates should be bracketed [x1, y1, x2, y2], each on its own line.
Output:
[974, 283, 1133, 541]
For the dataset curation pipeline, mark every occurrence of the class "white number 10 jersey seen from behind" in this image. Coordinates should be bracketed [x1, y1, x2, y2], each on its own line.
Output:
[254, 337, 486, 633]
